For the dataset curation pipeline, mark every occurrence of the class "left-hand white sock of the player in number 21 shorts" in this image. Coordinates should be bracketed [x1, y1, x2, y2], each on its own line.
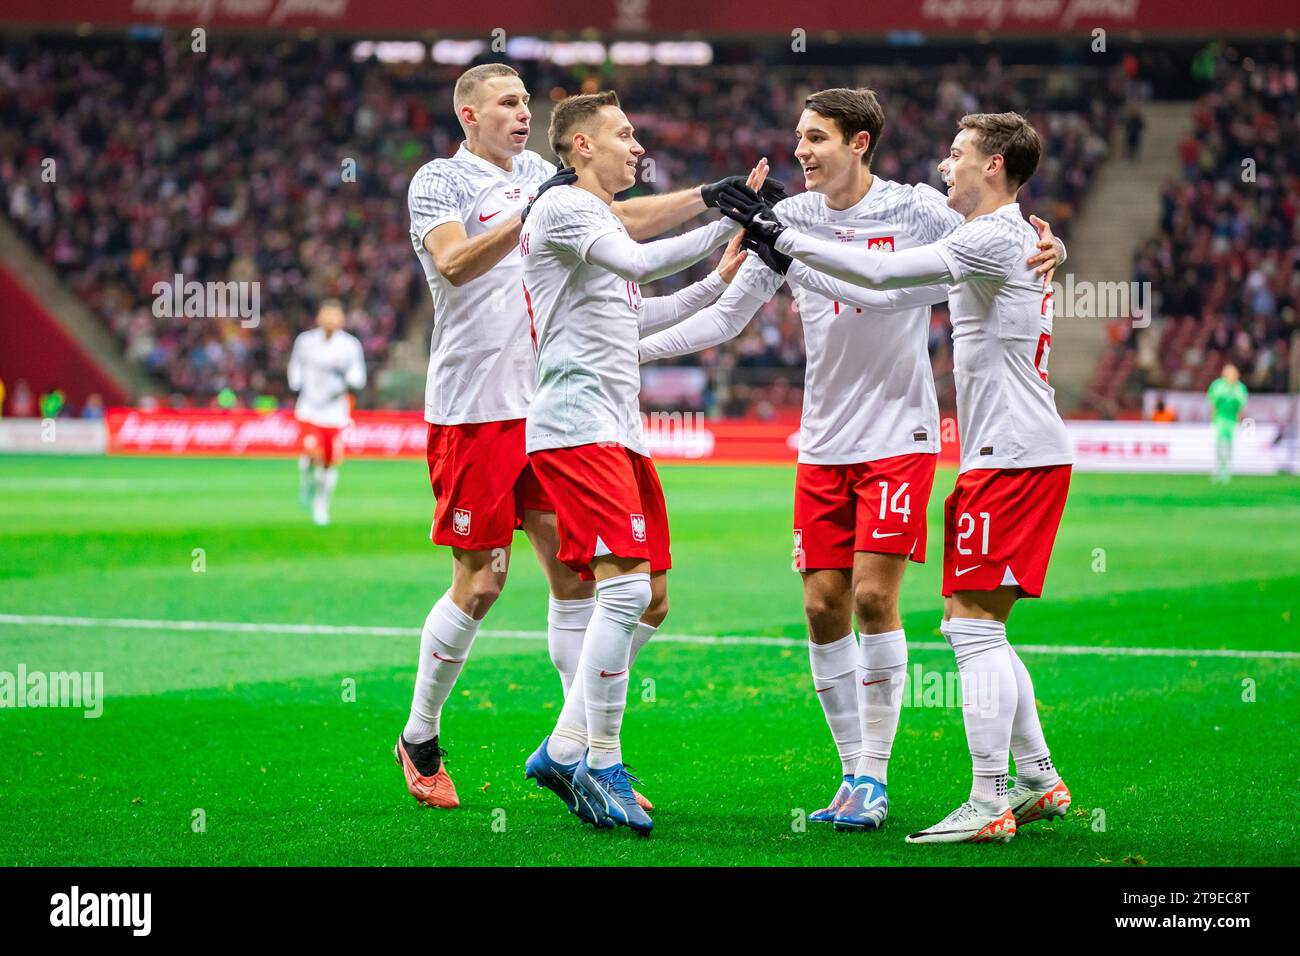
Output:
[940, 618, 1017, 804]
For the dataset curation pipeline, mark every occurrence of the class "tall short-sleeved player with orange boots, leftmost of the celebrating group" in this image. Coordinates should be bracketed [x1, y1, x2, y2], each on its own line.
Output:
[394, 64, 764, 808]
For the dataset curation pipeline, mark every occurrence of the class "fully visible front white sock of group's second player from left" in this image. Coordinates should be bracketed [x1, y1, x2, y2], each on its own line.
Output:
[575, 574, 650, 770]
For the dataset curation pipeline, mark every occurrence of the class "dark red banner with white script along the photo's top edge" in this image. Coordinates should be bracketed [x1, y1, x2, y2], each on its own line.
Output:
[0, 0, 1300, 39]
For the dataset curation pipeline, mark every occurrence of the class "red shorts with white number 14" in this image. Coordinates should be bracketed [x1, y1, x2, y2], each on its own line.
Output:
[794, 454, 939, 570]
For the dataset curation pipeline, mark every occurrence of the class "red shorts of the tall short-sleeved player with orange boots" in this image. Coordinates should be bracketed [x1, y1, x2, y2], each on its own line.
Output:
[428, 419, 555, 551]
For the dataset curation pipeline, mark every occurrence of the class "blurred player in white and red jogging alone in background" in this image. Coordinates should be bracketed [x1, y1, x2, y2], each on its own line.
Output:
[289, 299, 365, 525]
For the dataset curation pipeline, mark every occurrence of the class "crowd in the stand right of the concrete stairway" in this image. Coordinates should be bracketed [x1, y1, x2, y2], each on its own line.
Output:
[1086, 47, 1300, 416]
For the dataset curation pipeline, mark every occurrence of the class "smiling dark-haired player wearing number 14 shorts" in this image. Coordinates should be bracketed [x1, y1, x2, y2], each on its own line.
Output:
[641, 88, 1063, 831]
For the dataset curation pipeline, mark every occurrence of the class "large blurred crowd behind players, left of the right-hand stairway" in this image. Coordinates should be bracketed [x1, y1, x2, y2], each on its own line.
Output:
[0, 39, 1118, 415]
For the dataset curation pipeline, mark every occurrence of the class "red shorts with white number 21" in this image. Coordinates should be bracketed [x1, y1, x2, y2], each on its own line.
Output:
[944, 464, 1070, 597]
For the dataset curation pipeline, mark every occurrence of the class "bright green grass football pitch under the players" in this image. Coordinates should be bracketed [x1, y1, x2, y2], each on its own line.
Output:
[0, 457, 1300, 866]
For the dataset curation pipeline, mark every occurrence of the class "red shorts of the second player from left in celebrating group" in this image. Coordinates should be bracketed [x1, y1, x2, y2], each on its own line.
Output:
[528, 444, 672, 580]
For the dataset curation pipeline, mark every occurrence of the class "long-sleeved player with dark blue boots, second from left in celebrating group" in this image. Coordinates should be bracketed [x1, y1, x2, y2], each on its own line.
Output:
[519, 91, 766, 834]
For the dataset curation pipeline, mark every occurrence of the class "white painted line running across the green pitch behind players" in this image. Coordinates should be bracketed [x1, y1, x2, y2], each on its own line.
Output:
[0, 614, 1300, 661]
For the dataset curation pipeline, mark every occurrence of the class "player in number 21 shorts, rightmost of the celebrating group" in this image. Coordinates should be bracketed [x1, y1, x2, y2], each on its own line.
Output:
[724, 113, 1071, 843]
